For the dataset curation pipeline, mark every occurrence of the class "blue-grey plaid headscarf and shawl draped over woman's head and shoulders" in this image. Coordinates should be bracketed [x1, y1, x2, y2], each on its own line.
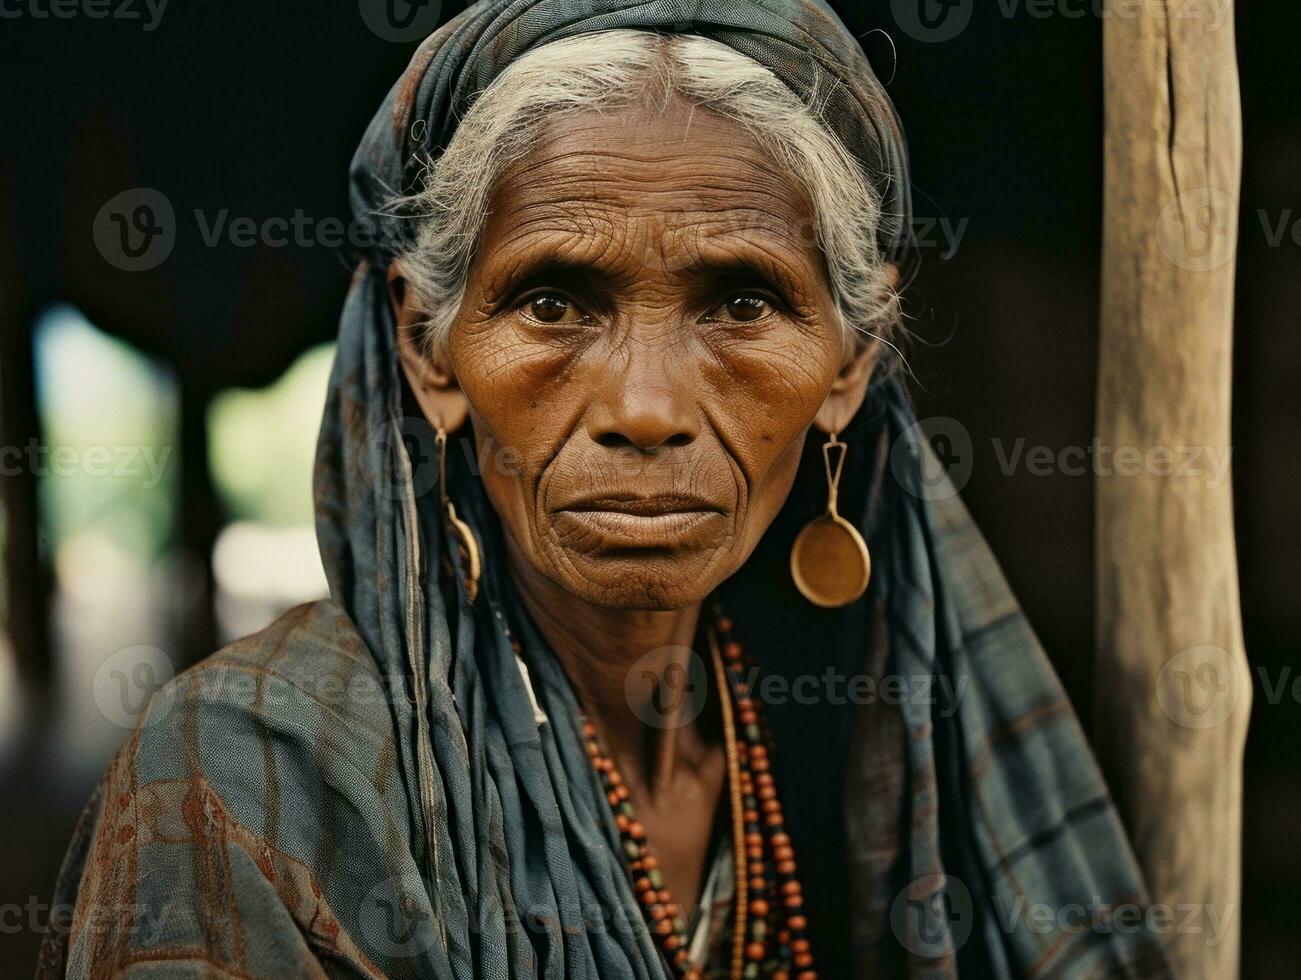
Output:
[40, 0, 1168, 980]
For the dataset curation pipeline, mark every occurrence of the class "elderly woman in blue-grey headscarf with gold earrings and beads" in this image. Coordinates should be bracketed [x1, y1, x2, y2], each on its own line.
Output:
[42, 0, 1168, 980]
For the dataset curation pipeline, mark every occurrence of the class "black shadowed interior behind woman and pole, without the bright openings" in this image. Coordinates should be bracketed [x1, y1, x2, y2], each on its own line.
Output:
[0, 0, 1301, 977]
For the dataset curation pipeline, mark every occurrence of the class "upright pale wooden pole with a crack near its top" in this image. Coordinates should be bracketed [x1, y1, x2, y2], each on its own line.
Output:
[1094, 0, 1252, 980]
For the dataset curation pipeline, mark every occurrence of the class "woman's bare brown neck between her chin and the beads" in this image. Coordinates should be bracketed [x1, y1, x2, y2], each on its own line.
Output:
[510, 551, 716, 796]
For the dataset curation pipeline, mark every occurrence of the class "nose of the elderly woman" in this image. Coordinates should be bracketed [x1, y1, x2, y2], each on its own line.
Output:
[587, 347, 700, 453]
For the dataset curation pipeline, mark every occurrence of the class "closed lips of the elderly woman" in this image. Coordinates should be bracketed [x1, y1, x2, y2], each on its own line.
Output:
[554, 495, 726, 549]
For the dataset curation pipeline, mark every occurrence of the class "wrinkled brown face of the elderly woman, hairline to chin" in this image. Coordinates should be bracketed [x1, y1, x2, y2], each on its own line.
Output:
[399, 97, 870, 609]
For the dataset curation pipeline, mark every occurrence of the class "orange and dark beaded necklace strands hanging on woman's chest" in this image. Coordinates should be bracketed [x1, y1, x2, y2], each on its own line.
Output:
[583, 616, 817, 980]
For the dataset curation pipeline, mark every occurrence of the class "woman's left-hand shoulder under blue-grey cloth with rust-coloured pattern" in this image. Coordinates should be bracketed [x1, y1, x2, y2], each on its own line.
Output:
[38, 601, 411, 977]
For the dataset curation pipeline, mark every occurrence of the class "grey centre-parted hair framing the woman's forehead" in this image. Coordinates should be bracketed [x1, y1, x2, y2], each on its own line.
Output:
[393, 30, 899, 369]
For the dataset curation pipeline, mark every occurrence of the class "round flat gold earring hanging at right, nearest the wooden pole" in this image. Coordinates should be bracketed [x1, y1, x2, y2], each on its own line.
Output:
[791, 432, 872, 609]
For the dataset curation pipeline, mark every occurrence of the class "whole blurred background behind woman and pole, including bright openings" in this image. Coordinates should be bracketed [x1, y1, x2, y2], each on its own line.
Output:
[0, 0, 1301, 977]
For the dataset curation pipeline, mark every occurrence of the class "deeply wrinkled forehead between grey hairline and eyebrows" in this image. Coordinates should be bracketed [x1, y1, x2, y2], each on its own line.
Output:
[480, 102, 824, 288]
